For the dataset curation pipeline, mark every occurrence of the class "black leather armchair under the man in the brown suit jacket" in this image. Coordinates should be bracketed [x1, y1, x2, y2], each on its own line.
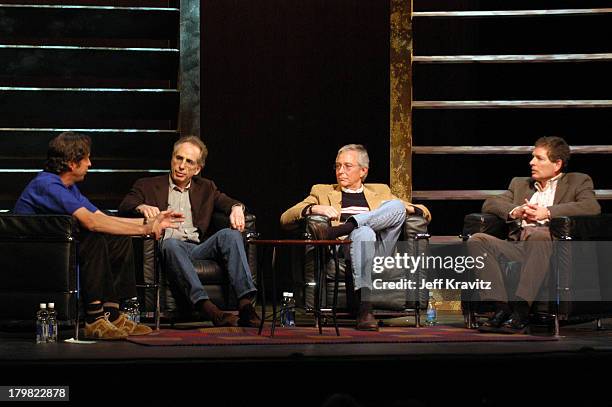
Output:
[462, 213, 612, 333]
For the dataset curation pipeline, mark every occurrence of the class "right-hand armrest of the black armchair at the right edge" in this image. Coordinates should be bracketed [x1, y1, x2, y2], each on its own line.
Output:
[550, 214, 612, 240]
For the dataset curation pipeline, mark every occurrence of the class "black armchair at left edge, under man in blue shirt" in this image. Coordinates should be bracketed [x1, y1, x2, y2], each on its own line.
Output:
[0, 214, 79, 337]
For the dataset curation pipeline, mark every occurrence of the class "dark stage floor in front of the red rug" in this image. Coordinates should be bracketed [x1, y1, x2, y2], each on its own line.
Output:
[0, 315, 612, 407]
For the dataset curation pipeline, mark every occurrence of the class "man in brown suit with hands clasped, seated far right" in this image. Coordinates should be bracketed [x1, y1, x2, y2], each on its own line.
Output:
[469, 137, 600, 333]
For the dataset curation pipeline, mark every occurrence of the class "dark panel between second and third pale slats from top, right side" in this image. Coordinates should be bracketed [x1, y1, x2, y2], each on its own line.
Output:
[413, 61, 612, 102]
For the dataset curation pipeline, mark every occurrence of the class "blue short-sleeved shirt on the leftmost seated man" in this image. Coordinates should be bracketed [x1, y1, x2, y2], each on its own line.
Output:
[14, 171, 98, 215]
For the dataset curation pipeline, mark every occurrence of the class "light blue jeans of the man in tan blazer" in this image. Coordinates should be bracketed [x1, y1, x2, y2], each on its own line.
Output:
[349, 199, 406, 290]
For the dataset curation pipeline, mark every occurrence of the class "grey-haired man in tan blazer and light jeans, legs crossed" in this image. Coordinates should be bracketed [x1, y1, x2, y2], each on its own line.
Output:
[281, 144, 431, 331]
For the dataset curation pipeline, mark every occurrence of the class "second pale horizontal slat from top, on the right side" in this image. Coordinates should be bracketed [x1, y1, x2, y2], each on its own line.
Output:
[412, 53, 612, 64]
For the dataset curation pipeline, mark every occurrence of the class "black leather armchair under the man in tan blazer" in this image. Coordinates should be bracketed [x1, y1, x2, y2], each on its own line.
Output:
[291, 215, 429, 325]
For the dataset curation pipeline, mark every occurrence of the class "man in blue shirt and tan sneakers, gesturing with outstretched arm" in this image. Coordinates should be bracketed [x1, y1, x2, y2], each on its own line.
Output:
[14, 132, 182, 339]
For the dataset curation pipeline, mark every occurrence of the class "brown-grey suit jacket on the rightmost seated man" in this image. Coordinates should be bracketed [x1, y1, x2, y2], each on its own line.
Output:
[482, 172, 601, 237]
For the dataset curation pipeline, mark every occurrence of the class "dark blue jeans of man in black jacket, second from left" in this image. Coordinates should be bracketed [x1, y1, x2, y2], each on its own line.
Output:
[161, 229, 257, 304]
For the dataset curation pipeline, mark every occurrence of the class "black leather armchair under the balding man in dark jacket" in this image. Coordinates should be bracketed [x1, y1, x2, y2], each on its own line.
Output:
[133, 212, 257, 321]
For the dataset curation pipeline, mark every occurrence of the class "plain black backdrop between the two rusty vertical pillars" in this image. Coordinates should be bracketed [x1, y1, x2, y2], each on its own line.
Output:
[201, 0, 389, 237]
